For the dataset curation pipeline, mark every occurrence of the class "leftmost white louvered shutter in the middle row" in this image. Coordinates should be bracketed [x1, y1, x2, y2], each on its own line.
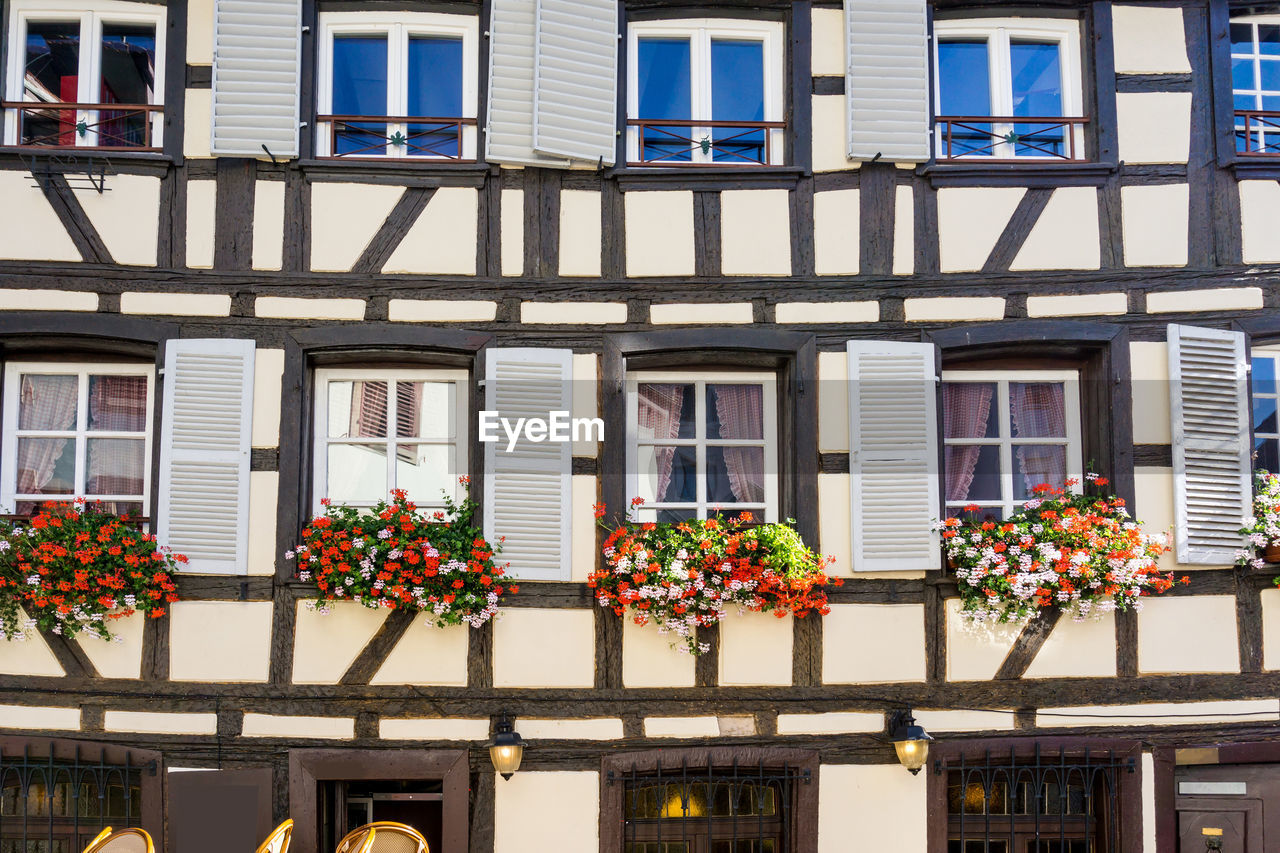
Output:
[156, 338, 253, 574]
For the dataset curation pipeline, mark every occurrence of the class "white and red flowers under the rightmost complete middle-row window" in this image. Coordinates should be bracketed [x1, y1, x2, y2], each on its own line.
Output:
[937, 474, 1188, 622]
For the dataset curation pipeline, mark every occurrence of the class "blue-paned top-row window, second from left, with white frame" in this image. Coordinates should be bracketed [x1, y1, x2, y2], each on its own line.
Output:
[316, 12, 480, 160]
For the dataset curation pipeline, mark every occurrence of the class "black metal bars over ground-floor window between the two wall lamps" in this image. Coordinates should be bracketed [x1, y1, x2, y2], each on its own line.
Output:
[608, 762, 810, 853]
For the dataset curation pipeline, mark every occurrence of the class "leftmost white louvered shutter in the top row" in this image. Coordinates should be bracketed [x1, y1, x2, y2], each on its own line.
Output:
[211, 0, 302, 158]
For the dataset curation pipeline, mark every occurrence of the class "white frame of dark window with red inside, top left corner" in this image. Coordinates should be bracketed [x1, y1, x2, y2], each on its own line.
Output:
[4, 0, 166, 147]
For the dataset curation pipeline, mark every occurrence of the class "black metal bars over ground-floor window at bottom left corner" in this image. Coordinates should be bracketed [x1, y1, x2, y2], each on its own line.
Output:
[0, 748, 145, 853]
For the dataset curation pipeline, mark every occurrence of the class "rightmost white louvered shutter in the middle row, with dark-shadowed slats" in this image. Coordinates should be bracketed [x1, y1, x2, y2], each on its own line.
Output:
[1169, 325, 1253, 565]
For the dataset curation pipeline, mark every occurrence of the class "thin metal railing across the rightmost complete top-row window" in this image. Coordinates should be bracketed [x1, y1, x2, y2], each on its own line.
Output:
[934, 115, 1089, 160]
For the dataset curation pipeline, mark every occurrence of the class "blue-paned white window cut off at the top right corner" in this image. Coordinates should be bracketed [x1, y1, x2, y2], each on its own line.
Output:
[1231, 15, 1280, 155]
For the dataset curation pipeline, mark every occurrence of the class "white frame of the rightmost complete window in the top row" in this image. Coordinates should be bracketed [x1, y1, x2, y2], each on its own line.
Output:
[933, 18, 1084, 163]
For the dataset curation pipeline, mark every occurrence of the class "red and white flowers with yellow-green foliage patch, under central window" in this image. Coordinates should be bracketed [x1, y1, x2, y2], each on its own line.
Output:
[588, 498, 841, 654]
